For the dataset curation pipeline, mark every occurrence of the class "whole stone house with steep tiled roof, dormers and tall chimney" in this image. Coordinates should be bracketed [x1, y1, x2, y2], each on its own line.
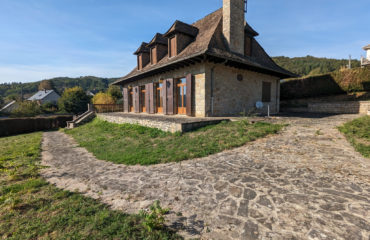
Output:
[113, 0, 294, 117]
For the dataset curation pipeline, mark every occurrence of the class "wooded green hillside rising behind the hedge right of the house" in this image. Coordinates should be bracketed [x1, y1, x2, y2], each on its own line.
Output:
[272, 56, 361, 76]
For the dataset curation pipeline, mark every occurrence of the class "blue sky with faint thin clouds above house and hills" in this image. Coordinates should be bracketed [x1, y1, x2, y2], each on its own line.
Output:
[0, 0, 370, 83]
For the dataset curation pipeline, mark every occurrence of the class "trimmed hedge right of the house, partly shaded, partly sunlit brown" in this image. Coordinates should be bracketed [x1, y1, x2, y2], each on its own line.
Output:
[281, 68, 370, 100]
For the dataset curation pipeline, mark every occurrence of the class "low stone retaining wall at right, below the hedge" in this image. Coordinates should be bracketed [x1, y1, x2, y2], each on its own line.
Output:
[308, 101, 370, 114]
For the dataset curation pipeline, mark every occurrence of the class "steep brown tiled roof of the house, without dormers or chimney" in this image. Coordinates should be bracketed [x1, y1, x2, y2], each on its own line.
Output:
[113, 8, 296, 85]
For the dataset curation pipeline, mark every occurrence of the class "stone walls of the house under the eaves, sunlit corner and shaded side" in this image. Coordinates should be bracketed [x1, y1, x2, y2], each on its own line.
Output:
[123, 63, 280, 117]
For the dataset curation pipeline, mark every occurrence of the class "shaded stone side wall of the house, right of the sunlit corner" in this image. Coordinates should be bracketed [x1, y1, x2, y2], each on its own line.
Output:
[205, 64, 280, 116]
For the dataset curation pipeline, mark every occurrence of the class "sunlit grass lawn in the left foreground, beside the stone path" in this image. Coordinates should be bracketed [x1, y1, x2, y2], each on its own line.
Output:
[0, 133, 179, 239]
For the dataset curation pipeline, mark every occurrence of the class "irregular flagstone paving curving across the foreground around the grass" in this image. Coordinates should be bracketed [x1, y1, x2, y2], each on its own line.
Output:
[42, 115, 370, 240]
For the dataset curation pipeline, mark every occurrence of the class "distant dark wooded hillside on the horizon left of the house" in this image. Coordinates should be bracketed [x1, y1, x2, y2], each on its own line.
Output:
[0, 76, 116, 98]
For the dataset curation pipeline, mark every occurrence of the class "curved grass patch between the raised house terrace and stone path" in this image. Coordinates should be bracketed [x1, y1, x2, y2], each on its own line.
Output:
[65, 119, 283, 165]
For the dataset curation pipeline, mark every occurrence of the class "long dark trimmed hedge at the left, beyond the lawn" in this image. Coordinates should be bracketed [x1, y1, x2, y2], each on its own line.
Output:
[0, 116, 73, 137]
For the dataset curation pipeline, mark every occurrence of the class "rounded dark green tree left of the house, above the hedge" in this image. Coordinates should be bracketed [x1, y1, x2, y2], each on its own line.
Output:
[58, 87, 90, 114]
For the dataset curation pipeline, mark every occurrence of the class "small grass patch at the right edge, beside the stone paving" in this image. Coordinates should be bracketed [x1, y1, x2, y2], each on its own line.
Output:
[339, 116, 370, 158]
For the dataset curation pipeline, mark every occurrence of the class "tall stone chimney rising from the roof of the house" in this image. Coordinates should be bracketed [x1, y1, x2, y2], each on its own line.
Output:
[223, 0, 245, 55]
